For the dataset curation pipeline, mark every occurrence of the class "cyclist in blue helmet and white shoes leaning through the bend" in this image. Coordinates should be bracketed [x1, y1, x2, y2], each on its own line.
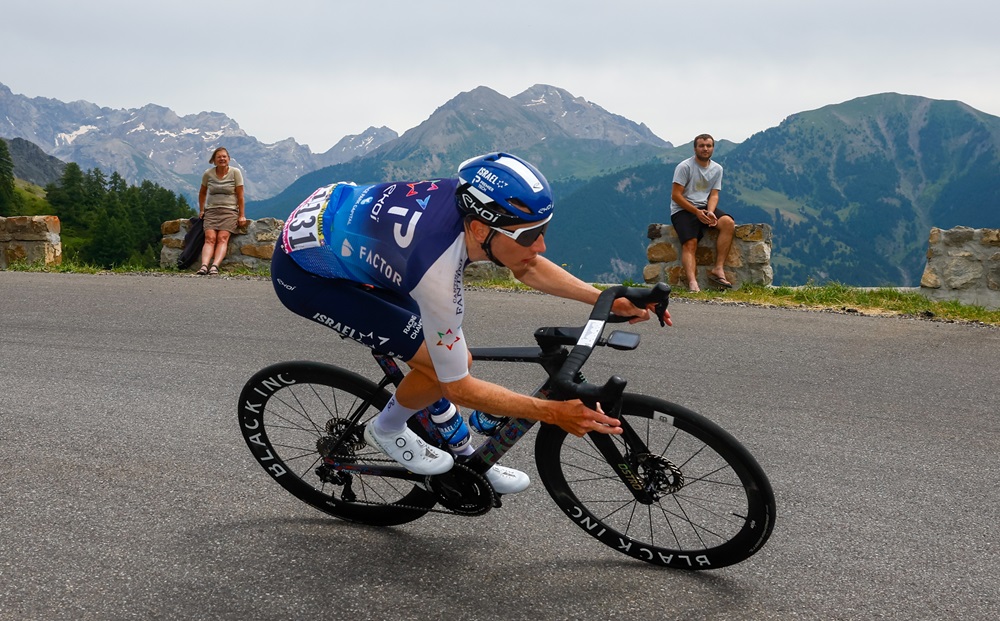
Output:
[271, 153, 670, 494]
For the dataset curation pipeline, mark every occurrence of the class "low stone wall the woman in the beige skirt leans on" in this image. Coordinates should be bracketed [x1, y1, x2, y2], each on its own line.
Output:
[160, 218, 284, 271]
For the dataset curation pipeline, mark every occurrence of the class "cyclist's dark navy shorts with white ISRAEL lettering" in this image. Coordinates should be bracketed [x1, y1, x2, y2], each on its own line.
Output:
[271, 241, 424, 360]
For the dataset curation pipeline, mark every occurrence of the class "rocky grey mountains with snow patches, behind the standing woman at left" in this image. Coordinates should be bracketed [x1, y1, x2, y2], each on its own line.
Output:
[0, 84, 398, 204]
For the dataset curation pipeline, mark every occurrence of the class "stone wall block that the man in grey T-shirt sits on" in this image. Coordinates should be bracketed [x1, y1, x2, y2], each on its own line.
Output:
[642, 224, 774, 290]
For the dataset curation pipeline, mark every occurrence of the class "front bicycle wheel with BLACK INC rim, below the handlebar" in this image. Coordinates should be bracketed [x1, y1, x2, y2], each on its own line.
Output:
[535, 394, 775, 569]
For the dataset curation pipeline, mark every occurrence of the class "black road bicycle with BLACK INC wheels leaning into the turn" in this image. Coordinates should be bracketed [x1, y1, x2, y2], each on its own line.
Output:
[238, 284, 775, 569]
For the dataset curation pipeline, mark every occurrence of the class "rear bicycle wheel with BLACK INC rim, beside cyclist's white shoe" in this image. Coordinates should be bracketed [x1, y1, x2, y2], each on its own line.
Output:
[238, 362, 435, 526]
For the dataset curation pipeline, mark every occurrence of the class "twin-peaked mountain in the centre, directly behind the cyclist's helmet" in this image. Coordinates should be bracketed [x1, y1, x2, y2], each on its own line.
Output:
[241, 84, 673, 218]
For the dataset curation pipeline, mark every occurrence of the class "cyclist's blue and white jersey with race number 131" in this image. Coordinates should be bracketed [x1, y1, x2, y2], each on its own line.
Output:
[280, 179, 469, 382]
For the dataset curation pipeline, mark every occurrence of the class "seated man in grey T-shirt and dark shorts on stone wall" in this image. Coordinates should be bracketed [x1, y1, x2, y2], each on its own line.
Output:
[670, 134, 736, 291]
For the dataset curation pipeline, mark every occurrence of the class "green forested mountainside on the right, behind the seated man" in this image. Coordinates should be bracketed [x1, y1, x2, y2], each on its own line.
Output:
[549, 94, 1000, 286]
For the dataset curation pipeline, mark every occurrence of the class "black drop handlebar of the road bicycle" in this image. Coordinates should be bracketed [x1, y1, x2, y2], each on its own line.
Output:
[553, 283, 670, 409]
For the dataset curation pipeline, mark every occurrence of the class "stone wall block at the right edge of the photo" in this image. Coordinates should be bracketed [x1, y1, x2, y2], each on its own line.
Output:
[920, 226, 1000, 309]
